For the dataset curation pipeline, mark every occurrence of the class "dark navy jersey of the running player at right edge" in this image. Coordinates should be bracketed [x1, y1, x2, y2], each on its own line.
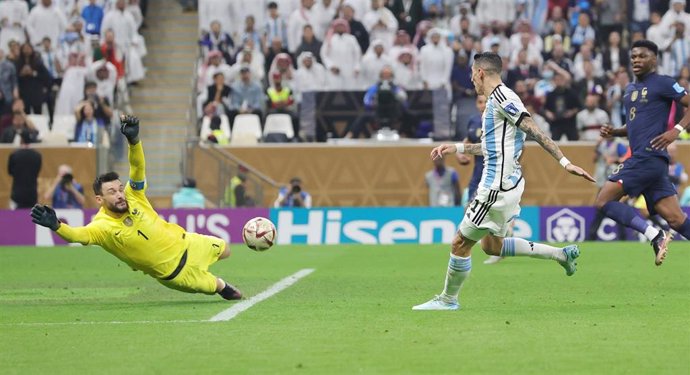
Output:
[623, 73, 687, 160]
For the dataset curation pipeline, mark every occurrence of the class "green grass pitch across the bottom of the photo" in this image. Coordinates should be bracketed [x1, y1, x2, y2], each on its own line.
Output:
[0, 242, 690, 374]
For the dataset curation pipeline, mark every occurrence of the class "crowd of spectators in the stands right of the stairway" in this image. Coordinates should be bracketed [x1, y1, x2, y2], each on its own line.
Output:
[192, 0, 690, 140]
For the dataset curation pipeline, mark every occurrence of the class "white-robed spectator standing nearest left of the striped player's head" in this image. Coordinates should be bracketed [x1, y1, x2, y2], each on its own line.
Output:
[419, 29, 453, 94]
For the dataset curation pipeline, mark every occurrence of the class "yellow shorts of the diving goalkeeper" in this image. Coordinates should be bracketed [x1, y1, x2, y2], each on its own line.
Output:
[158, 233, 226, 294]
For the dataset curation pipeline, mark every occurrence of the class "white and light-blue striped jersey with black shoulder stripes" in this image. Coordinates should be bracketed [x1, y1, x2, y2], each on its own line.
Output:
[479, 84, 530, 191]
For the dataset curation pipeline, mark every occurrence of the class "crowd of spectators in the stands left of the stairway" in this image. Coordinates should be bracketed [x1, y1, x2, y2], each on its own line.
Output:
[0, 0, 146, 144]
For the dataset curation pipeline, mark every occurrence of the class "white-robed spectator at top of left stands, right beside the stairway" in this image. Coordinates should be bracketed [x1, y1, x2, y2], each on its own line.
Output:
[101, 0, 146, 83]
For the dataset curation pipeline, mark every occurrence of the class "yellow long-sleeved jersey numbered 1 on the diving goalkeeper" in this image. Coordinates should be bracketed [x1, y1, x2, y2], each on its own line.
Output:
[57, 142, 189, 278]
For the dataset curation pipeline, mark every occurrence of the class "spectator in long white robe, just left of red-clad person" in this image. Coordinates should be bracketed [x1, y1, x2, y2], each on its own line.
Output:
[55, 53, 87, 115]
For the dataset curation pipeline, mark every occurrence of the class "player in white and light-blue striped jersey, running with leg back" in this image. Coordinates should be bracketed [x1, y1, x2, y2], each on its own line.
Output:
[412, 52, 594, 310]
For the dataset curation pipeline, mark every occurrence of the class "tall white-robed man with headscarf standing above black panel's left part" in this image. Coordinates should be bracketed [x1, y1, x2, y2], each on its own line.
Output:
[321, 18, 362, 90]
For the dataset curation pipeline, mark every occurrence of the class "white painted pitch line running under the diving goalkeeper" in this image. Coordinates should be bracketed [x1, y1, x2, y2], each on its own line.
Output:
[0, 268, 314, 327]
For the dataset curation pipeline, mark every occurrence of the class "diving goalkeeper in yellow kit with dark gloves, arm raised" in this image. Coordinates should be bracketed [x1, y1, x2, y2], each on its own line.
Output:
[31, 116, 242, 300]
